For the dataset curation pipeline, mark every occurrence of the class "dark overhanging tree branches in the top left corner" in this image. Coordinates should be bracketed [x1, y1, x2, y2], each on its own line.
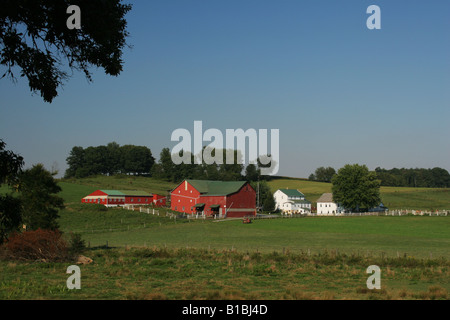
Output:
[0, 0, 131, 103]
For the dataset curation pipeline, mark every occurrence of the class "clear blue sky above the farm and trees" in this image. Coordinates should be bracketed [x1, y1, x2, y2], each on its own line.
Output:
[0, 0, 450, 177]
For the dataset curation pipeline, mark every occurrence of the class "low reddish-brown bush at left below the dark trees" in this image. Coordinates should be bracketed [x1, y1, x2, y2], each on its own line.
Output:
[4, 229, 68, 262]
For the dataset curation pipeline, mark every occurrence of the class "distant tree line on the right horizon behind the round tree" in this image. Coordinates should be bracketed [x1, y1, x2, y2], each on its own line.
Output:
[309, 167, 450, 188]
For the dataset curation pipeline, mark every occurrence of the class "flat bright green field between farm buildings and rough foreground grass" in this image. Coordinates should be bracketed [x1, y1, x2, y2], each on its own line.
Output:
[63, 212, 450, 258]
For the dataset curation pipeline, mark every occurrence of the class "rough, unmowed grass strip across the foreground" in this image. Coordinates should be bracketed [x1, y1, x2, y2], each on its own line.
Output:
[0, 248, 450, 300]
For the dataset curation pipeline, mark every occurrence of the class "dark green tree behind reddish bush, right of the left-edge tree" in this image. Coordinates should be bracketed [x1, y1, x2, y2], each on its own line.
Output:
[19, 164, 64, 230]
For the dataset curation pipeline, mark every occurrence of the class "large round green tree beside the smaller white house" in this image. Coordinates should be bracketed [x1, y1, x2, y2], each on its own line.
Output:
[332, 164, 381, 212]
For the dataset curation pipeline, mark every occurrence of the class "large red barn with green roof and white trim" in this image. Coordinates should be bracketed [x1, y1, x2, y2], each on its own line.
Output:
[170, 180, 256, 218]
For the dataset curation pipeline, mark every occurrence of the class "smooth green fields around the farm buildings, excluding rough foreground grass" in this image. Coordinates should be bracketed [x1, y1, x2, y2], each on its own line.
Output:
[51, 177, 450, 257]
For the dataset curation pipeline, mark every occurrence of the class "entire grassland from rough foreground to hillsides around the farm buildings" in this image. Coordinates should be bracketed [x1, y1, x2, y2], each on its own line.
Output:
[0, 177, 450, 300]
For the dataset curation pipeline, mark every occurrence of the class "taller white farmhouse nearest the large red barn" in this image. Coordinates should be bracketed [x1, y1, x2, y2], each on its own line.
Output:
[273, 189, 311, 214]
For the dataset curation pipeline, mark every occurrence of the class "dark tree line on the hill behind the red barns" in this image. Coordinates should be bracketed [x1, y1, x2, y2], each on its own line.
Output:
[65, 142, 275, 210]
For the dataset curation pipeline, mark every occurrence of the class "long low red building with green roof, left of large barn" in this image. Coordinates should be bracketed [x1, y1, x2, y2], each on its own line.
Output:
[81, 190, 166, 207]
